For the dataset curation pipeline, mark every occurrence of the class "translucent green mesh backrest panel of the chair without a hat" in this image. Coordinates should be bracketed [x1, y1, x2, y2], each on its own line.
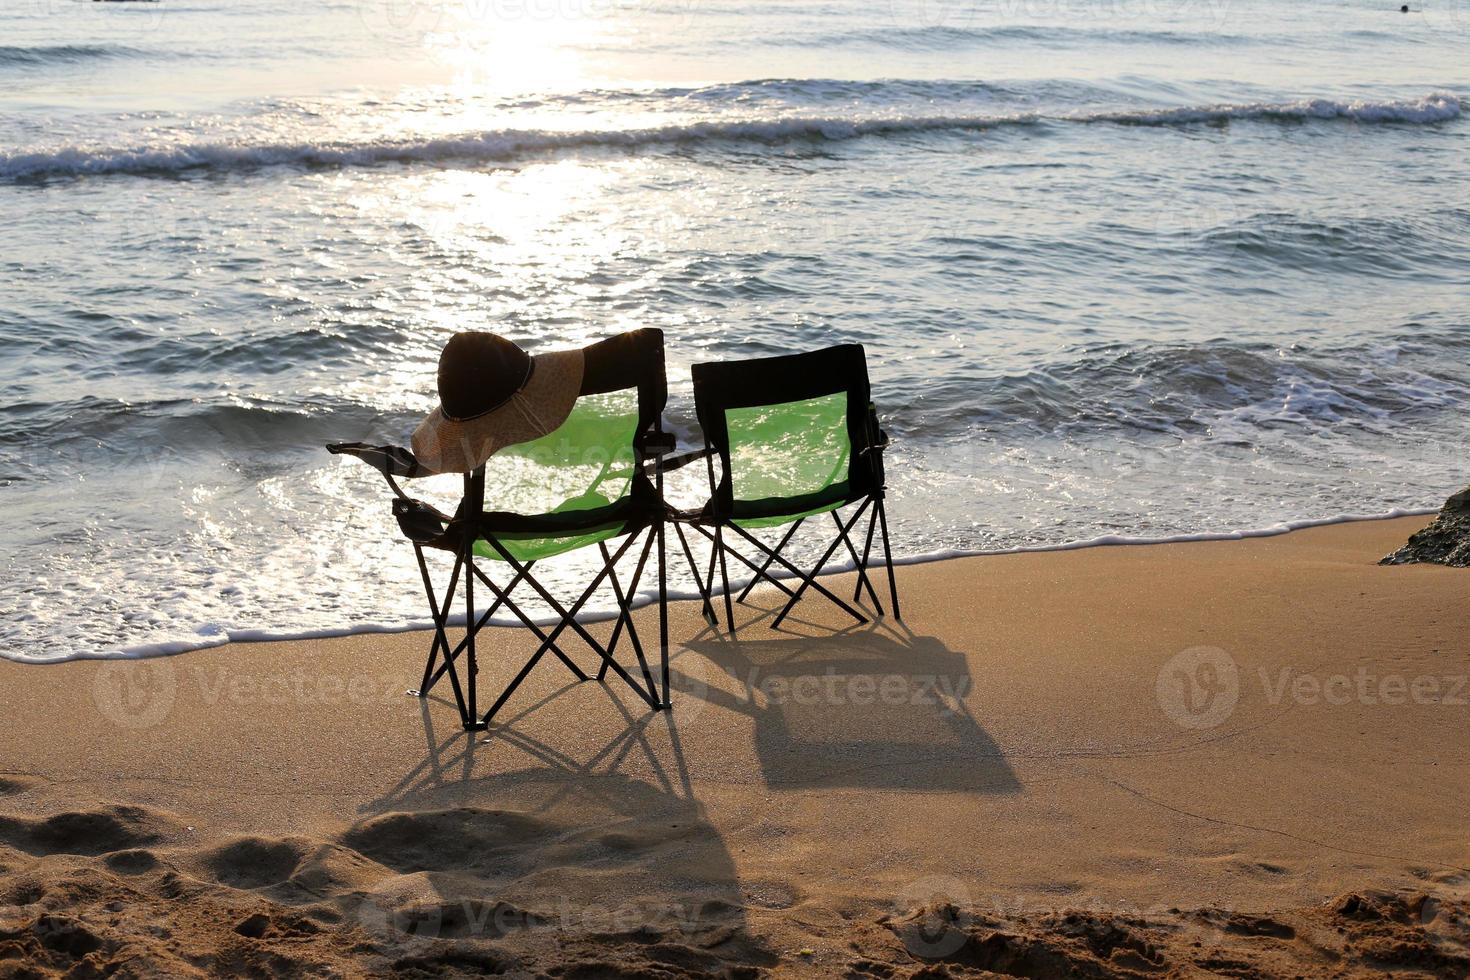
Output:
[725, 391, 853, 501]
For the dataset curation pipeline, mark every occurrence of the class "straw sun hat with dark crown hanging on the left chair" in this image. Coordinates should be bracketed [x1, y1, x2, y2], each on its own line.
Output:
[413, 332, 582, 473]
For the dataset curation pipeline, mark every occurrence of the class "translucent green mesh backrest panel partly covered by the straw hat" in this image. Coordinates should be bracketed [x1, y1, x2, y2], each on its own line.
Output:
[485, 391, 638, 514]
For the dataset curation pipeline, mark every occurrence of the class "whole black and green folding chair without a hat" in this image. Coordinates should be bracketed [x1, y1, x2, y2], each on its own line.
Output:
[676, 344, 900, 632]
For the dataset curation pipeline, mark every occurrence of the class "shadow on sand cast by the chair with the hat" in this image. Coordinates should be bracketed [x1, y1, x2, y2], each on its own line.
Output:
[344, 685, 775, 974]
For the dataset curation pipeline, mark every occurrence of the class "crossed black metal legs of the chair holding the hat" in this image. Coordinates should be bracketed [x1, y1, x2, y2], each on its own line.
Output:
[409, 526, 669, 730]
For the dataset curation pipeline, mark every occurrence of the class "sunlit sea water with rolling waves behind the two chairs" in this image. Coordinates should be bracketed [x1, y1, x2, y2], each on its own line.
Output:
[0, 0, 1470, 660]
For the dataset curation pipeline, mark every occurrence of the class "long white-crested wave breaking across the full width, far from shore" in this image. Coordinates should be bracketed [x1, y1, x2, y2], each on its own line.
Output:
[0, 93, 1460, 181]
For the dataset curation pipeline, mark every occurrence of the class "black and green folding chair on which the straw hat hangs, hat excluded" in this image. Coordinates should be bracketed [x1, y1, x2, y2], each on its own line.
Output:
[328, 329, 673, 729]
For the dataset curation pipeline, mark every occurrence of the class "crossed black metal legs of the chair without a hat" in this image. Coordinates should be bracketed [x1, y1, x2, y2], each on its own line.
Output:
[675, 497, 903, 633]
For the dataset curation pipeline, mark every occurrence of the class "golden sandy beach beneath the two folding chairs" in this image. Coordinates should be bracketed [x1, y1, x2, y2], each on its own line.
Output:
[0, 519, 1470, 977]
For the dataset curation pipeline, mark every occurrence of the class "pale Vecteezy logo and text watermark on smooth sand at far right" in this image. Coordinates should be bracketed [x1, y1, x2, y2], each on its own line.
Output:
[1154, 646, 1470, 729]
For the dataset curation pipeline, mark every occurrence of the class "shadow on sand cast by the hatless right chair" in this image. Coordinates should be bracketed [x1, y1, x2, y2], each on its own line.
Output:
[670, 610, 1020, 793]
